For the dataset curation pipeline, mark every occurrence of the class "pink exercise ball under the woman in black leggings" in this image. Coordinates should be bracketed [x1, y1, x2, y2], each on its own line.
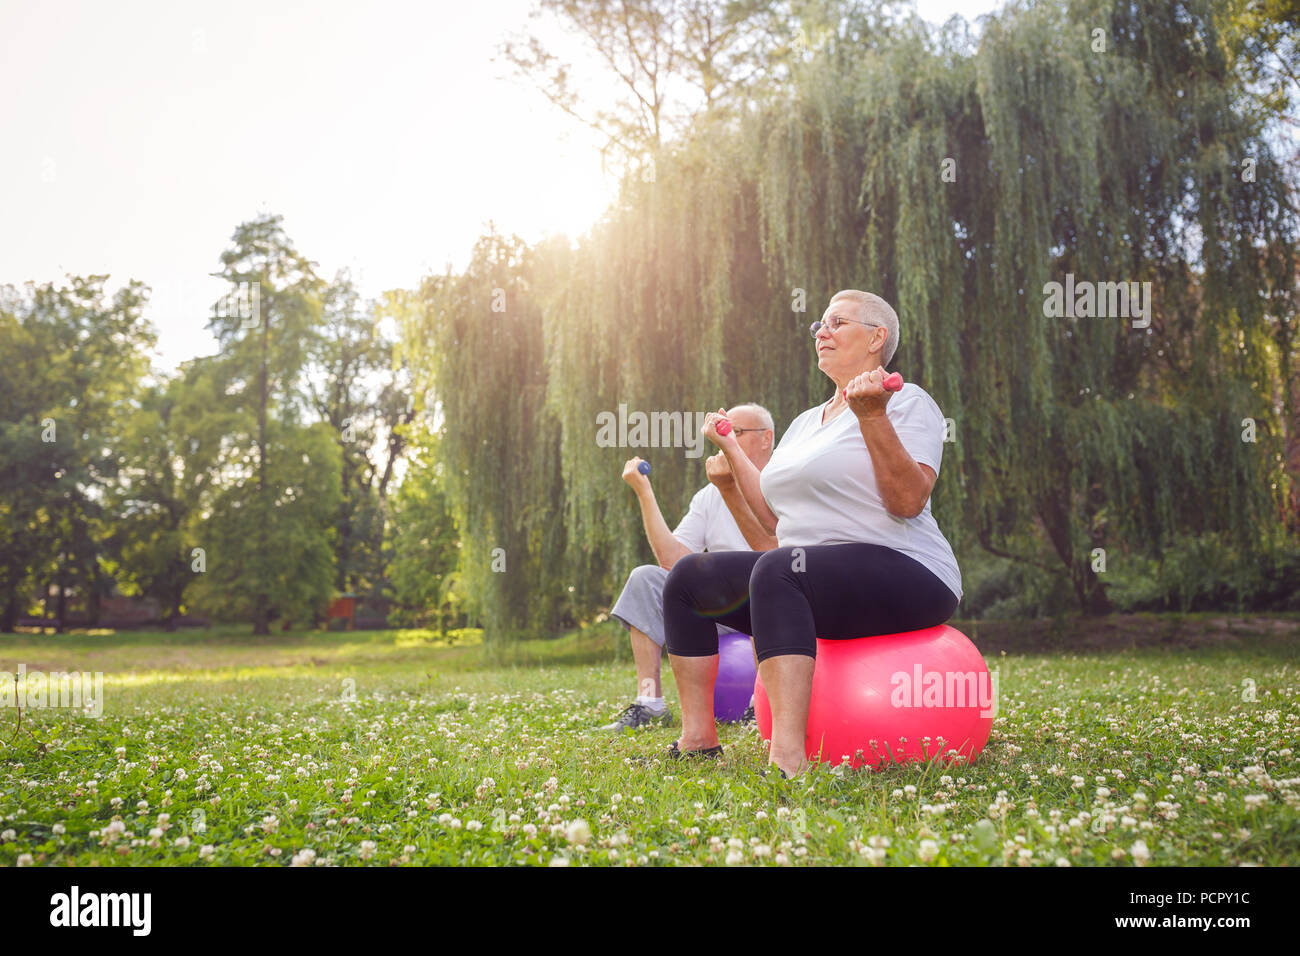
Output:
[754, 624, 997, 767]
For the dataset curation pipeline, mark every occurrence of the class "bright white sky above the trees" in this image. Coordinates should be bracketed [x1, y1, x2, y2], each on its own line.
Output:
[0, 0, 997, 369]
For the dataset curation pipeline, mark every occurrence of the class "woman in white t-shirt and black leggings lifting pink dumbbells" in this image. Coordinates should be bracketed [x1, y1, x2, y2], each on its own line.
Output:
[663, 289, 962, 777]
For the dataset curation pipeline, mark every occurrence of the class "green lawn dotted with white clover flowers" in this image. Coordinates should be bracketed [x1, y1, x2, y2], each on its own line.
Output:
[0, 622, 1300, 866]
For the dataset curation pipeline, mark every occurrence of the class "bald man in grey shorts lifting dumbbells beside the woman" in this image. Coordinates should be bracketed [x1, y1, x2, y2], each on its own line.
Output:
[602, 405, 776, 732]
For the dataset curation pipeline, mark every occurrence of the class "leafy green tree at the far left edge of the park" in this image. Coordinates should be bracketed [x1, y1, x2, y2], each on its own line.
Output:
[0, 276, 155, 630]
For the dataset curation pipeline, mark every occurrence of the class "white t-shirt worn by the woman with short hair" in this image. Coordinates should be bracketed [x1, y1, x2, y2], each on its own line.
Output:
[759, 382, 962, 600]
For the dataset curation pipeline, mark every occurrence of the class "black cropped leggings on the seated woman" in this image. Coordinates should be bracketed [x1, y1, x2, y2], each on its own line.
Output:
[663, 544, 957, 661]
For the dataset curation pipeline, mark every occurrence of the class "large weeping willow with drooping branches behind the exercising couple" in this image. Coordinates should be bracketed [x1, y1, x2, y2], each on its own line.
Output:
[400, 1, 1297, 642]
